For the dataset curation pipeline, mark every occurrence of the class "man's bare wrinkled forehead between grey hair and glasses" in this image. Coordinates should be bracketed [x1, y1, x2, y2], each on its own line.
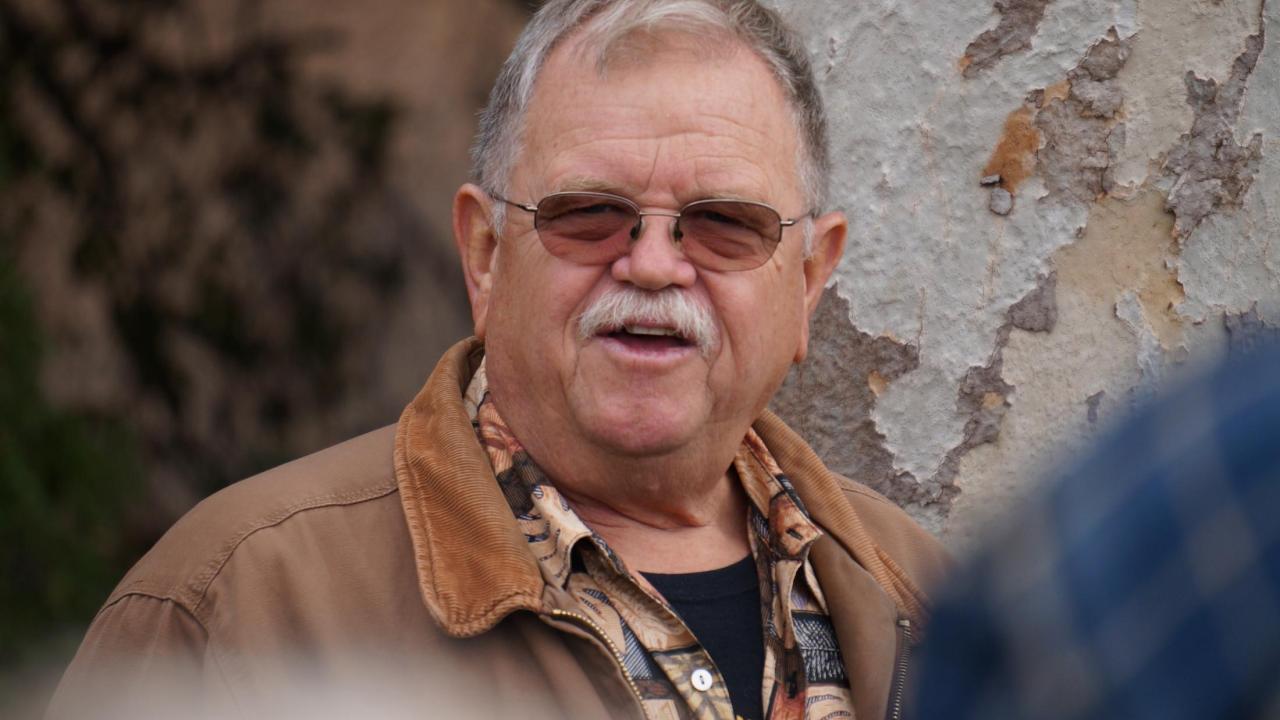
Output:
[517, 27, 800, 200]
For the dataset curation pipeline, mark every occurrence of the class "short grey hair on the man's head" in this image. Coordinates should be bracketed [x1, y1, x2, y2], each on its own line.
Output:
[471, 0, 831, 245]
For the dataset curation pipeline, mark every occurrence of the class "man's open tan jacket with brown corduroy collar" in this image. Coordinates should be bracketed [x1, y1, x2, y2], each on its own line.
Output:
[50, 340, 948, 719]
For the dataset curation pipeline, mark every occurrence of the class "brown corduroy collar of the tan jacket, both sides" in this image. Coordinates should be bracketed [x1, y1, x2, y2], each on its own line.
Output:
[394, 338, 924, 637]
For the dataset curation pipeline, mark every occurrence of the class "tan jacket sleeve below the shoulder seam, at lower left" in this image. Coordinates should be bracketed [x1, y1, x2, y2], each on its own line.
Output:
[46, 594, 217, 719]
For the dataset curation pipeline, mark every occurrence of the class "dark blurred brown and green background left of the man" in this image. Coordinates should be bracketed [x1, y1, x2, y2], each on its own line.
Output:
[0, 0, 407, 670]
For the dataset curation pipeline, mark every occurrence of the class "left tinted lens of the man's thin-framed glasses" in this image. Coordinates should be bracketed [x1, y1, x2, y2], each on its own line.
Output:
[534, 192, 639, 264]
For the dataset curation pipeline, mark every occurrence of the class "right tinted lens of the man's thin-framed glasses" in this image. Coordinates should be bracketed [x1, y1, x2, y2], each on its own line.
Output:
[680, 200, 782, 270]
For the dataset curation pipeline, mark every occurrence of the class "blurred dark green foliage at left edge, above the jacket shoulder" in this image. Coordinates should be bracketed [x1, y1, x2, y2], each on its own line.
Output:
[0, 253, 142, 669]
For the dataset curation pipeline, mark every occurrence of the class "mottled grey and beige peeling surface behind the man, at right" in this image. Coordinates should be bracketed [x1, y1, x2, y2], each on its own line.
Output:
[774, 0, 1280, 547]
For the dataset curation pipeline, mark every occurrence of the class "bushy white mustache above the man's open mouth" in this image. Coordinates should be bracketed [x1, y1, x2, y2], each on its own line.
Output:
[577, 286, 719, 357]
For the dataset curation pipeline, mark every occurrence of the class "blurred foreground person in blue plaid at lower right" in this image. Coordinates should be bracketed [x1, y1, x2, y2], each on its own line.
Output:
[914, 346, 1280, 720]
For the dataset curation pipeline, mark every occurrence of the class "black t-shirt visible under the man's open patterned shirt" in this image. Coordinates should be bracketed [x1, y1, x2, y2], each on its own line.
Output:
[644, 555, 764, 720]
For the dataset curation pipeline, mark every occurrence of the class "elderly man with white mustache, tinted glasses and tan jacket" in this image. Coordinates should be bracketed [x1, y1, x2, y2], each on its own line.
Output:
[54, 0, 946, 719]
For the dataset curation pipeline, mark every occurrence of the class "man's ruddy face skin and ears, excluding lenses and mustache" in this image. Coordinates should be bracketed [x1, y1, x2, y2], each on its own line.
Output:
[460, 32, 842, 456]
